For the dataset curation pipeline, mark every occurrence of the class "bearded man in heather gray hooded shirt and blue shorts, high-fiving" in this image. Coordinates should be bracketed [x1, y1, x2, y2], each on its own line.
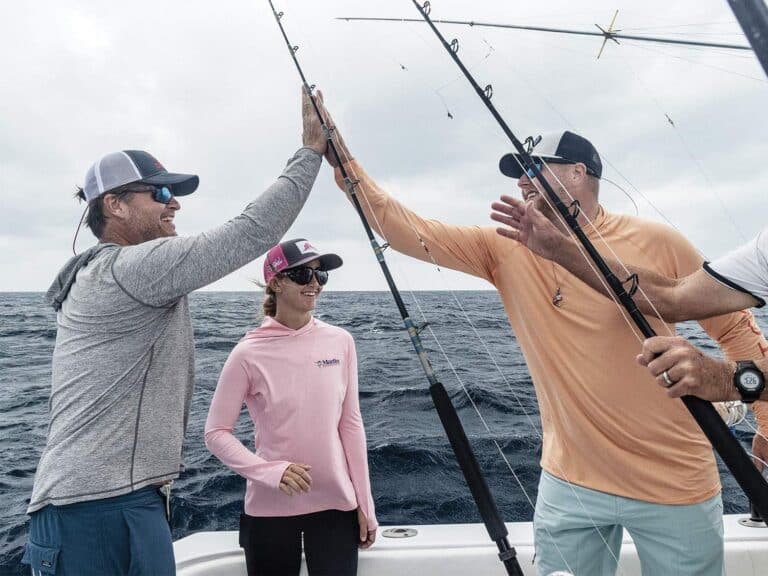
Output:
[23, 94, 326, 576]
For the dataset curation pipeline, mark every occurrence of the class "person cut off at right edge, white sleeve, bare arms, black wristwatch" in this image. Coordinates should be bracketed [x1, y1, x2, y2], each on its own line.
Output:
[491, 182, 768, 470]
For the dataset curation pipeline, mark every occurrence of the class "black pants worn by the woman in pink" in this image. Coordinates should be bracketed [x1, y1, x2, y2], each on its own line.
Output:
[240, 510, 359, 576]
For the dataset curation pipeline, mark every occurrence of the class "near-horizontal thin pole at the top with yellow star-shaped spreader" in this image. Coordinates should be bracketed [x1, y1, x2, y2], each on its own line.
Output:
[336, 12, 752, 58]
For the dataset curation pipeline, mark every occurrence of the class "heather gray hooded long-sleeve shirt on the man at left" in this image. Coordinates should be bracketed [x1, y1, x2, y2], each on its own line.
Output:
[27, 148, 321, 513]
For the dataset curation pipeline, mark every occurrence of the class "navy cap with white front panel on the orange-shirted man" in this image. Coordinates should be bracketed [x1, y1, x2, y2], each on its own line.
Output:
[499, 130, 603, 178]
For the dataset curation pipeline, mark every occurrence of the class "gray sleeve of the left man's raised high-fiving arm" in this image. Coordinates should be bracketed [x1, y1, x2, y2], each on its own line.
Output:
[113, 148, 321, 306]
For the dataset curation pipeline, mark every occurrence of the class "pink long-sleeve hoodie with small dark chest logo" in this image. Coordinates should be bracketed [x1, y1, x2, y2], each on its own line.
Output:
[205, 317, 378, 530]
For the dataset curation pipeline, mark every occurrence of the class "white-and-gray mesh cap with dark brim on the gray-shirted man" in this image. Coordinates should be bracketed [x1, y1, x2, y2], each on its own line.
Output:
[83, 150, 200, 202]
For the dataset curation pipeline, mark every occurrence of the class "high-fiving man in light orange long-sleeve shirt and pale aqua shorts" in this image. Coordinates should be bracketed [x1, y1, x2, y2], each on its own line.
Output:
[327, 130, 766, 576]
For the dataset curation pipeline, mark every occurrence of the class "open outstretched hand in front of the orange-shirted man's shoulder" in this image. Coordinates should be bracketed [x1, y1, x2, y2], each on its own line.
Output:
[491, 195, 569, 260]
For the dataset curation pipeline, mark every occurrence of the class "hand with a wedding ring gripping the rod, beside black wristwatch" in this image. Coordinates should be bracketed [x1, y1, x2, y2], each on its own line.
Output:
[637, 336, 741, 402]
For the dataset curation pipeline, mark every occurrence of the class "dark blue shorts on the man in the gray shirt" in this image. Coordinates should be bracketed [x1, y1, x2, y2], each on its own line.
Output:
[21, 486, 176, 576]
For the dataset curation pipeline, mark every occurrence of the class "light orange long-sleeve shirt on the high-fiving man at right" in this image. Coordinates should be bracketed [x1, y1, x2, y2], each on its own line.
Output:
[336, 160, 768, 504]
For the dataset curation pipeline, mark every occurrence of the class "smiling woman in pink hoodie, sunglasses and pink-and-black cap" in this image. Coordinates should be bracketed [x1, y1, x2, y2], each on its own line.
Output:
[205, 239, 378, 575]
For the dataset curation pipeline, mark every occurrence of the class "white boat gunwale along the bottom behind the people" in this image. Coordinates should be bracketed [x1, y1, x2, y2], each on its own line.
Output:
[174, 514, 768, 576]
